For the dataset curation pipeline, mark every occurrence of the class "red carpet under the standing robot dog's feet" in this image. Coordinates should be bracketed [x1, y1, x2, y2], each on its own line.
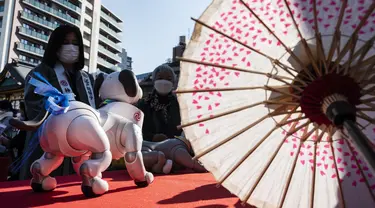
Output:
[0, 171, 256, 208]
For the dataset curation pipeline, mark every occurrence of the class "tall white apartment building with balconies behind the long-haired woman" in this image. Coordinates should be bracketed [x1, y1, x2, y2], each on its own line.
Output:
[0, 0, 122, 73]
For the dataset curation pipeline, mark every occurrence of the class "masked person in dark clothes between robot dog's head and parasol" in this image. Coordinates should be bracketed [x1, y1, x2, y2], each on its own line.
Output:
[137, 64, 182, 142]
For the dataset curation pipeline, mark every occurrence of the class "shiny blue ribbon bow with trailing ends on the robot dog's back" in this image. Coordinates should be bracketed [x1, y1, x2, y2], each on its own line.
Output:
[11, 72, 74, 173]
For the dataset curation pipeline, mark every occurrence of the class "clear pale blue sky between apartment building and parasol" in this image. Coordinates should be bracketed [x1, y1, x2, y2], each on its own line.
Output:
[102, 0, 212, 74]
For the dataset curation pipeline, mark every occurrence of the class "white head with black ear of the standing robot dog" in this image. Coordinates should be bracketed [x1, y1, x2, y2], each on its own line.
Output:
[97, 70, 143, 104]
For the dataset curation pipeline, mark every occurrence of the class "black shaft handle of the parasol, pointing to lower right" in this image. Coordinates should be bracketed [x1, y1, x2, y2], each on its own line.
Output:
[325, 100, 375, 172]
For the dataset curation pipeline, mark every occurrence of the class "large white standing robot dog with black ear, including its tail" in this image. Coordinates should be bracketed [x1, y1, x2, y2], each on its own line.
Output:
[11, 70, 154, 197]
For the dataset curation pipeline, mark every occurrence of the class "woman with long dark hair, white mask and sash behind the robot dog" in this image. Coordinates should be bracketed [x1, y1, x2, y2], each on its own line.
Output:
[21, 25, 98, 179]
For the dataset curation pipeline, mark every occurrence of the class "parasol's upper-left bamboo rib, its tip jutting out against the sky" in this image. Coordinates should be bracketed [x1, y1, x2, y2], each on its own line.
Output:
[191, 18, 306, 81]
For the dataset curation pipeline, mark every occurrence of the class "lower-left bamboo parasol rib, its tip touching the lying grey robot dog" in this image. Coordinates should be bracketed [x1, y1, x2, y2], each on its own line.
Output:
[193, 105, 298, 160]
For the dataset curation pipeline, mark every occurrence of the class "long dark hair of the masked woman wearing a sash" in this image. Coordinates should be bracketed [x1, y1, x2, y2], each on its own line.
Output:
[42, 25, 85, 70]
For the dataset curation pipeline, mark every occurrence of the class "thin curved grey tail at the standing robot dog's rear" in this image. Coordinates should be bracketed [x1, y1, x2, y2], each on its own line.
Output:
[9, 111, 49, 131]
